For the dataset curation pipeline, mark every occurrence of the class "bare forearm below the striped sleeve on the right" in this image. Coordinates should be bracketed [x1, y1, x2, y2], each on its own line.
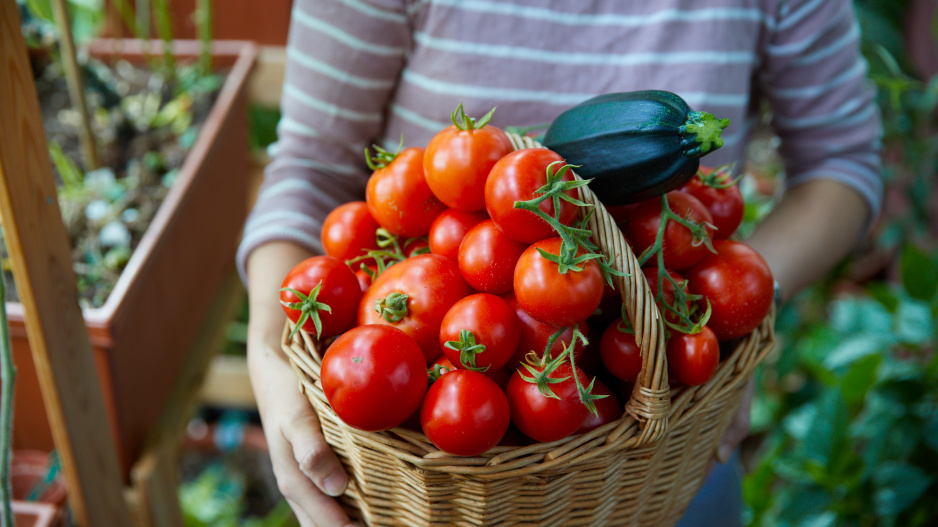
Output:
[746, 180, 869, 299]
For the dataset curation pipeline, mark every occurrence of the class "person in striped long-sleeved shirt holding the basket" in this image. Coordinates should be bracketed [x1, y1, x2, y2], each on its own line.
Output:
[238, 0, 882, 527]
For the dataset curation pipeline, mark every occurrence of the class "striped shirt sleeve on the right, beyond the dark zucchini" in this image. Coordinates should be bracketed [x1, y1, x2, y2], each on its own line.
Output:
[758, 0, 883, 226]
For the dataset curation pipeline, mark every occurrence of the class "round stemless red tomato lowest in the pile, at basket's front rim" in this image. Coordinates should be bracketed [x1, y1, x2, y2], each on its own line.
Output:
[420, 370, 511, 456]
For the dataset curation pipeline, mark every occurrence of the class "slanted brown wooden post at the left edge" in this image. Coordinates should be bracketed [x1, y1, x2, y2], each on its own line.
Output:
[0, 0, 130, 527]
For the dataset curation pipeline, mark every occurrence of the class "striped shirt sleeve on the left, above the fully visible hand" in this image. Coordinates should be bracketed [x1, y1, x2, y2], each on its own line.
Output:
[236, 0, 411, 283]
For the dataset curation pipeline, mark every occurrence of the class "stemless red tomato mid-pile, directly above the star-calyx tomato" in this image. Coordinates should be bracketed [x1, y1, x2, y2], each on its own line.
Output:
[459, 220, 526, 295]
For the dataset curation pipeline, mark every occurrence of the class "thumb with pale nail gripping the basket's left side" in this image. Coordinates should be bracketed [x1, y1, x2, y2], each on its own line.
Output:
[283, 413, 348, 496]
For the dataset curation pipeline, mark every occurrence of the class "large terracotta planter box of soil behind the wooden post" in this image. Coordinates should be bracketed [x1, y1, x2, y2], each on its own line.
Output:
[7, 40, 257, 473]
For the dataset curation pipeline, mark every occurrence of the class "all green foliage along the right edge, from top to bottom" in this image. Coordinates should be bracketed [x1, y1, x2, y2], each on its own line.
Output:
[744, 0, 938, 527]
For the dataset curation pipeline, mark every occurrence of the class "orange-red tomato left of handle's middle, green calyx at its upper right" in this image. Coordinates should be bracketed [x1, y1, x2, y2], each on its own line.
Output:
[514, 237, 604, 327]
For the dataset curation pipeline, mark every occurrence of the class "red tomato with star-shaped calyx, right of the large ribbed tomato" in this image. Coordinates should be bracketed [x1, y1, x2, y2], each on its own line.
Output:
[440, 293, 521, 371]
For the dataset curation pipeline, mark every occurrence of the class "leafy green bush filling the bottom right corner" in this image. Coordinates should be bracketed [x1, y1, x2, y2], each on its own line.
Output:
[744, 245, 938, 526]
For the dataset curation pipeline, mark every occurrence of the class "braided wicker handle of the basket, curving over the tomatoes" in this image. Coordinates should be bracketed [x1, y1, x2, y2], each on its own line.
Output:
[508, 133, 671, 446]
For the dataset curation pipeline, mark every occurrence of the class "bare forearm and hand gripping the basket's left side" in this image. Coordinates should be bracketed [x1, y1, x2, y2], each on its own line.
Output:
[248, 243, 351, 527]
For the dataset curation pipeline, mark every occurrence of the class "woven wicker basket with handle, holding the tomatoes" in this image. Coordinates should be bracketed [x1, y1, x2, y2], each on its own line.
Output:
[282, 134, 774, 527]
